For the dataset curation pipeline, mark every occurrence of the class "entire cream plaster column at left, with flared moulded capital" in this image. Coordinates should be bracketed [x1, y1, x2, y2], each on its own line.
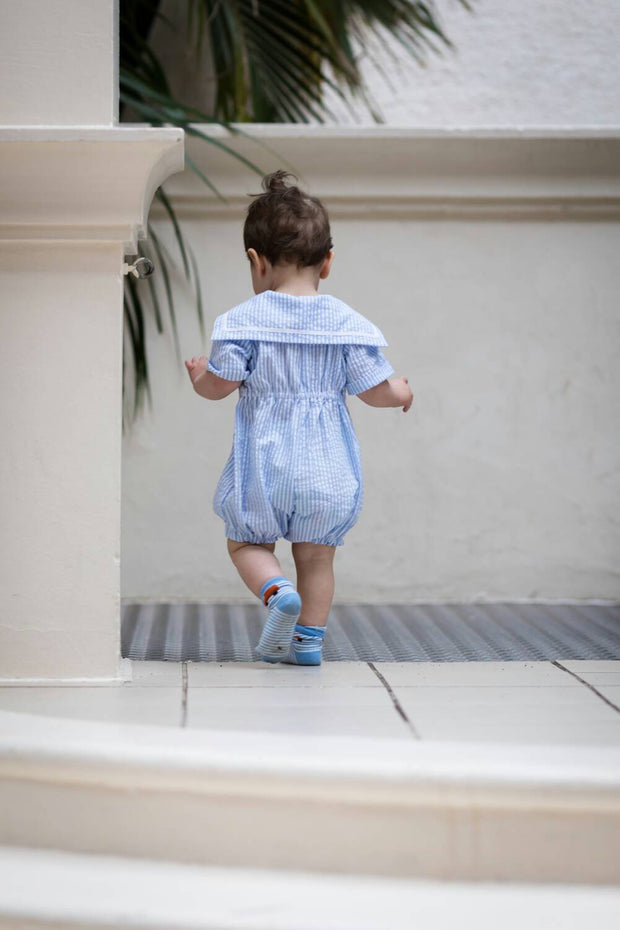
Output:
[0, 0, 184, 682]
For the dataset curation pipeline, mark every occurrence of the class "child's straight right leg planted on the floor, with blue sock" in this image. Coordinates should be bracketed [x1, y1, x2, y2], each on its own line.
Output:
[285, 543, 336, 665]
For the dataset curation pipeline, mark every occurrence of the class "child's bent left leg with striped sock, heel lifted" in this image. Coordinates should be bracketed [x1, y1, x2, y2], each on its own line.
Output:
[228, 539, 301, 662]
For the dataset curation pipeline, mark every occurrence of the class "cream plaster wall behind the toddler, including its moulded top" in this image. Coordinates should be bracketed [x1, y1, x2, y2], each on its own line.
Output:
[122, 127, 620, 601]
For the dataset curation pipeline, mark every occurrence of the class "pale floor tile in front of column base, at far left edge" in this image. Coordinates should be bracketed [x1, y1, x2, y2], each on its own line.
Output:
[0, 685, 182, 726]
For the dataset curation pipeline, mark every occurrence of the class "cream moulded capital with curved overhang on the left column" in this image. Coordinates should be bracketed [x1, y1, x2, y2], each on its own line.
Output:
[0, 125, 184, 254]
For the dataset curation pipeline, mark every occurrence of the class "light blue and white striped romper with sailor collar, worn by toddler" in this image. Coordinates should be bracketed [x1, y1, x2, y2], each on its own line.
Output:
[208, 291, 394, 546]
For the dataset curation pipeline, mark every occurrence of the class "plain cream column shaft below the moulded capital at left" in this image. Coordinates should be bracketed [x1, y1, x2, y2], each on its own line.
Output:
[0, 241, 122, 677]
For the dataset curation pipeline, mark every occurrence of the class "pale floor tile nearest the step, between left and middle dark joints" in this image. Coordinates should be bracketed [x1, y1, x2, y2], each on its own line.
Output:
[187, 703, 413, 739]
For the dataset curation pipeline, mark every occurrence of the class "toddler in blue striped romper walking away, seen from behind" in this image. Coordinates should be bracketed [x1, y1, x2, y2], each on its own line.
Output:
[185, 171, 413, 665]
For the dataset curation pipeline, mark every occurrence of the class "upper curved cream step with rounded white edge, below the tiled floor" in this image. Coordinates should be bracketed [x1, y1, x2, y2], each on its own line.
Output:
[0, 711, 620, 884]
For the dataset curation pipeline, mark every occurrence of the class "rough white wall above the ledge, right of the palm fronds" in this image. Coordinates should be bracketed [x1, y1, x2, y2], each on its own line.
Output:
[326, 0, 620, 128]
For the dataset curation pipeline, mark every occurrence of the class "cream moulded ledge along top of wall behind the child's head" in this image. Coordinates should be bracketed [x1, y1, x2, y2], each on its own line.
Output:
[154, 124, 620, 220]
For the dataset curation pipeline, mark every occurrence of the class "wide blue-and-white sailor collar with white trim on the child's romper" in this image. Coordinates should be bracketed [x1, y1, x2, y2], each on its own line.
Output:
[211, 291, 387, 346]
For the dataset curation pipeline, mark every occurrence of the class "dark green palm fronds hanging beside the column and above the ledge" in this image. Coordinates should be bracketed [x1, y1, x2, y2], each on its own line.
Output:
[119, 0, 470, 423]
